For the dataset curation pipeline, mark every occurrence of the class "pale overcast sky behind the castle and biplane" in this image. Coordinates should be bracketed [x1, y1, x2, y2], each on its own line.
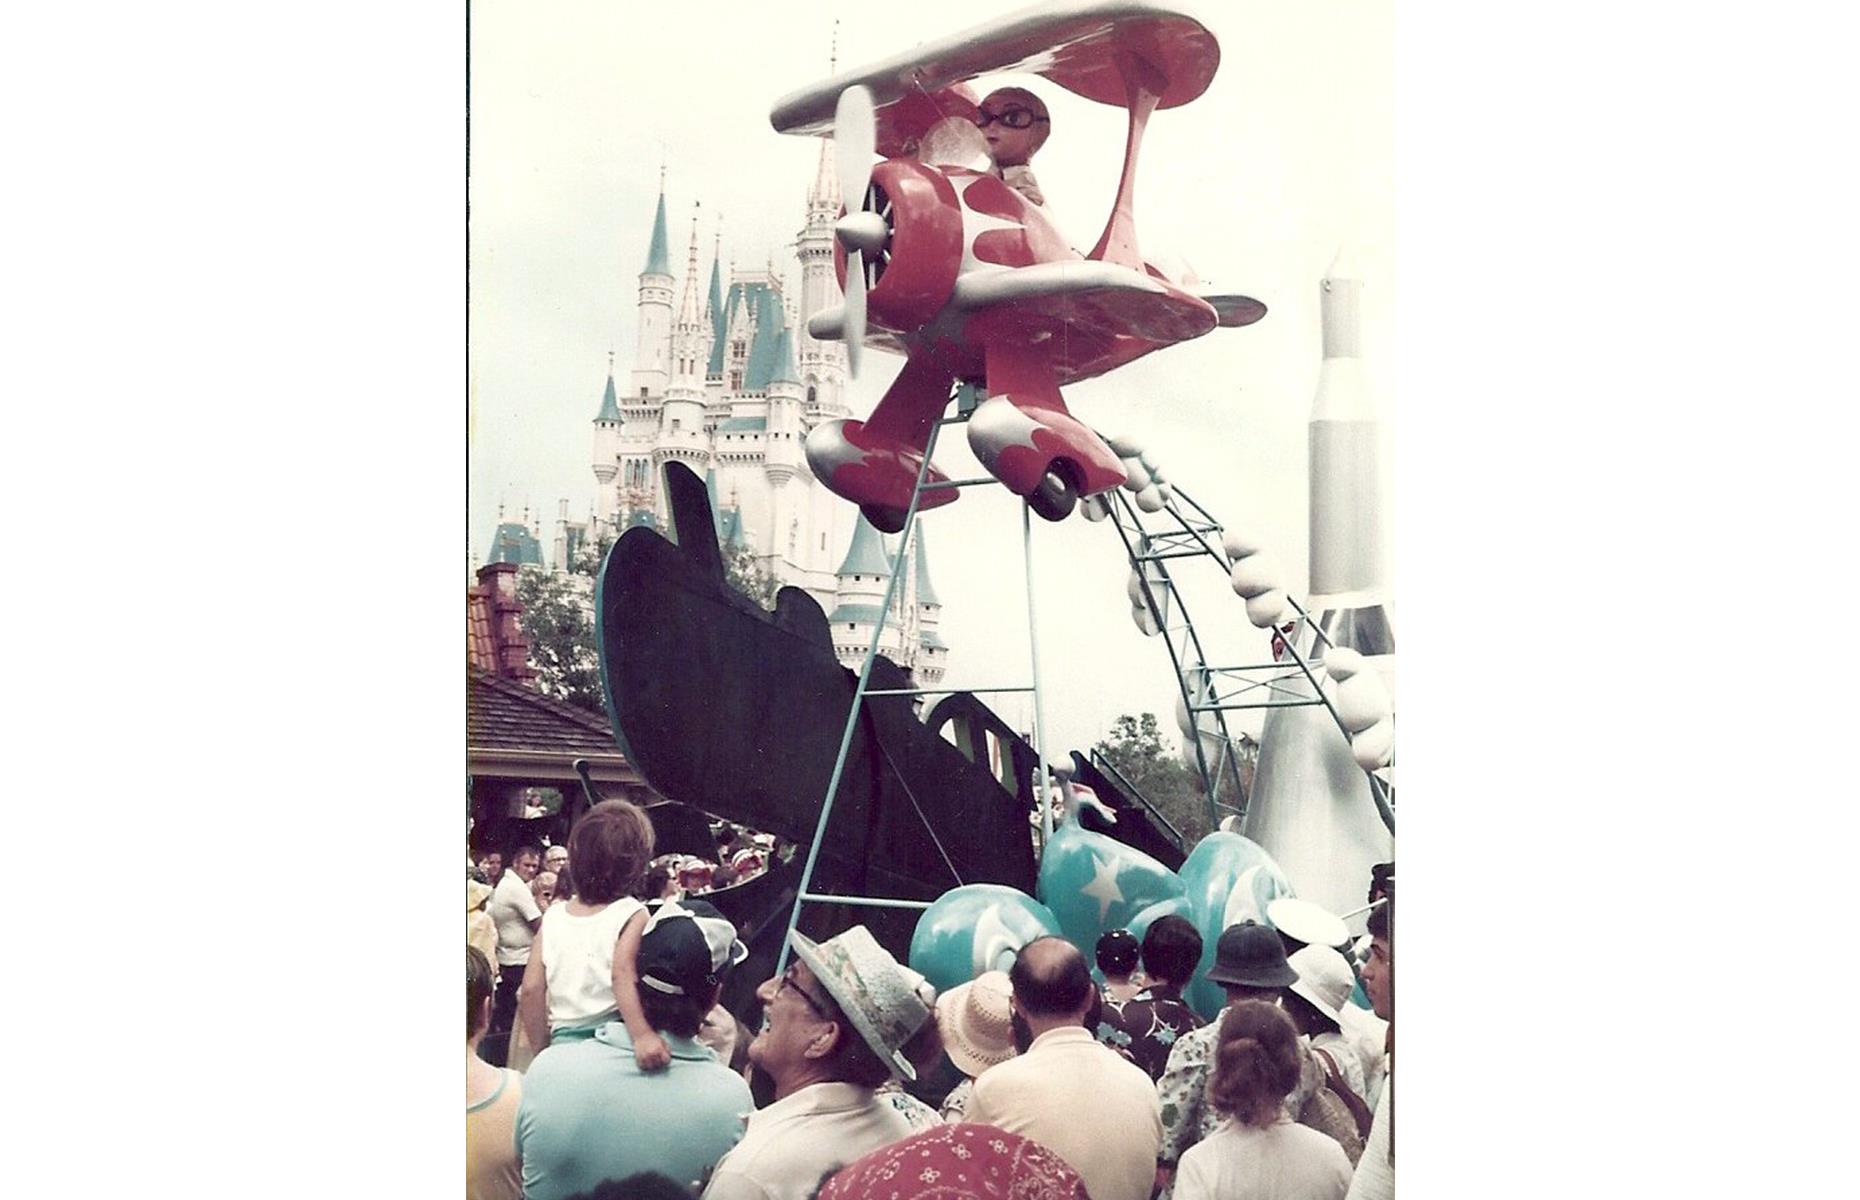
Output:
[469, 0, 1397, 752]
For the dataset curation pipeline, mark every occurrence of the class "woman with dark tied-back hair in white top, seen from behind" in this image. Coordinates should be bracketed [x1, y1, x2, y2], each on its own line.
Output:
[1174, 1001, 1350, 1200]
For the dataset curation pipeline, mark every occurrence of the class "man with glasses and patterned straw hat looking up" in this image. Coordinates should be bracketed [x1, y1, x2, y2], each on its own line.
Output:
[703, 925, 941, 1200]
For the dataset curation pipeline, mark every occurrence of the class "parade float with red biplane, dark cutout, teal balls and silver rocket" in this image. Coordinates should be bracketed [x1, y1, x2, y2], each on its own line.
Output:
[595, 2, 1395, 1016]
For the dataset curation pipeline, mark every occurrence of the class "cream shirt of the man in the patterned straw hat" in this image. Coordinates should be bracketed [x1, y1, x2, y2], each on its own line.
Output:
[703, 1083, 911, 1200]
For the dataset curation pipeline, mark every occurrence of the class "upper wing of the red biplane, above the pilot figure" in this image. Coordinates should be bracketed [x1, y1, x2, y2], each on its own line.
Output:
[768, 0, 1220, 134]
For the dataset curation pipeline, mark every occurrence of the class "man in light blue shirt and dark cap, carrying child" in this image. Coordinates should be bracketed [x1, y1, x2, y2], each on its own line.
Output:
[517, 900, 755, 1200]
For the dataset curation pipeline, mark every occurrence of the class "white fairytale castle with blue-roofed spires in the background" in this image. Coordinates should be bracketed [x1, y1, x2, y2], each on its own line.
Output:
[489, 140, 949, 687]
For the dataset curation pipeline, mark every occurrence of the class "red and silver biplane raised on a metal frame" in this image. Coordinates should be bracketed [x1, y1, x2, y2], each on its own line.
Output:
[770, 0, 1265, 532]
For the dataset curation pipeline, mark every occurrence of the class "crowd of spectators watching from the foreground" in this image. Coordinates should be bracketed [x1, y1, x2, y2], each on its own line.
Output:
[465, 800, 1393, 1200]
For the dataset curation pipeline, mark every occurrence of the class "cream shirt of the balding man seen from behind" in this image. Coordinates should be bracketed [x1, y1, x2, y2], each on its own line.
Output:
[967, 1027, 1163, 1200]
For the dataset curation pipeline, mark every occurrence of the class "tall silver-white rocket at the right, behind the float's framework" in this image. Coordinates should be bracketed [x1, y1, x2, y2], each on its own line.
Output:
[1241, 253, 1395, 921]
